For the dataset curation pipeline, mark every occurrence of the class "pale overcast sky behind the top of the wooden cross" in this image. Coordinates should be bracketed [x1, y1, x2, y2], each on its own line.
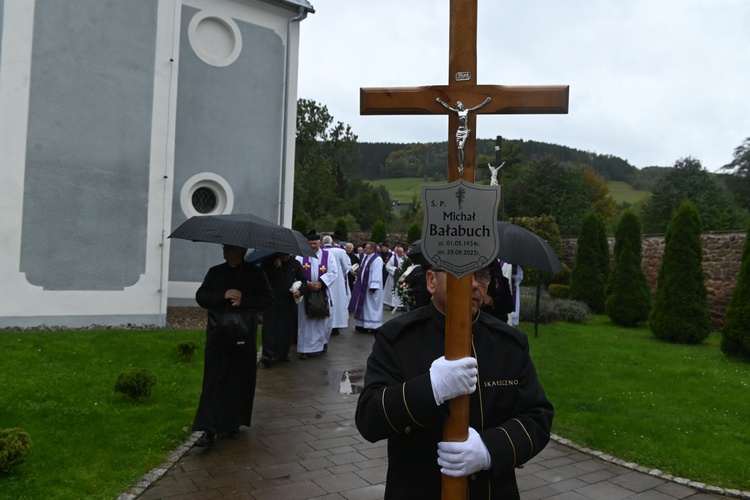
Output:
[298, 0, 750, 171]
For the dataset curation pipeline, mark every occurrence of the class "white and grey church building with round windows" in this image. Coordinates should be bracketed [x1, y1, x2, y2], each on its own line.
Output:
[0, 0, 314, 327]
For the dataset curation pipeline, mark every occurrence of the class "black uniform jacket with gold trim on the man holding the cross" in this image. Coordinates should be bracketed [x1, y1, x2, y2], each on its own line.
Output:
[355, 303, 554, 500]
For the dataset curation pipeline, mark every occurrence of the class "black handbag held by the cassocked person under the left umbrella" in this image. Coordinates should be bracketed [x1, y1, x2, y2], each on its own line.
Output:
[206, 309, 258, 349]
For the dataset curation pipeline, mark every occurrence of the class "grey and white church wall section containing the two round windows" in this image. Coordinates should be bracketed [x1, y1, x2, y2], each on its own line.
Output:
[169, 0, 299, 305]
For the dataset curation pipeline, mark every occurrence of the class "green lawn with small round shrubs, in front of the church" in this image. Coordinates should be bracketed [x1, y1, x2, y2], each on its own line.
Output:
[0, 330, 204, 499]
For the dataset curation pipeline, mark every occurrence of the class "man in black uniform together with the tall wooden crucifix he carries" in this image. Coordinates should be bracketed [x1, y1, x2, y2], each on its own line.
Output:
[356, 0, 568, 500]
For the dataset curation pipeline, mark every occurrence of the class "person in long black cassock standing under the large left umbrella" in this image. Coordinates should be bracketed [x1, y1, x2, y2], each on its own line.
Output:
[193, 245, 274, 447]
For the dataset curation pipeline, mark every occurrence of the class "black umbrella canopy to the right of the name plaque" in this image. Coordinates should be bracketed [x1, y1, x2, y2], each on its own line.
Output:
[497, 221, 563, 273]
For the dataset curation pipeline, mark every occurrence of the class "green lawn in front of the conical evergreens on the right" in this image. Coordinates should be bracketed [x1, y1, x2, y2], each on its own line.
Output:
[521, 316, 750, 490]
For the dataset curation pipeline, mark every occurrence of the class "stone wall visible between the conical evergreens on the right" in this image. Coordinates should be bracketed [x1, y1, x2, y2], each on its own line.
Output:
[563, 231, 746, 330]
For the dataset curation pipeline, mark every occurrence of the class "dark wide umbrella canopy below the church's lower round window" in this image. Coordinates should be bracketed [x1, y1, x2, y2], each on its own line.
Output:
[169, 214, 315, 257]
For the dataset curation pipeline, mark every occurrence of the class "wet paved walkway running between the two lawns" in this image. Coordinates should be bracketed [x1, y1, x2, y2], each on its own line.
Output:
[131, 320, 740, 500]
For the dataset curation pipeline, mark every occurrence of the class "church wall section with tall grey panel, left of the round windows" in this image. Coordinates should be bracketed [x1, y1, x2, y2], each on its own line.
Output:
[0, 0, 181, 326]
